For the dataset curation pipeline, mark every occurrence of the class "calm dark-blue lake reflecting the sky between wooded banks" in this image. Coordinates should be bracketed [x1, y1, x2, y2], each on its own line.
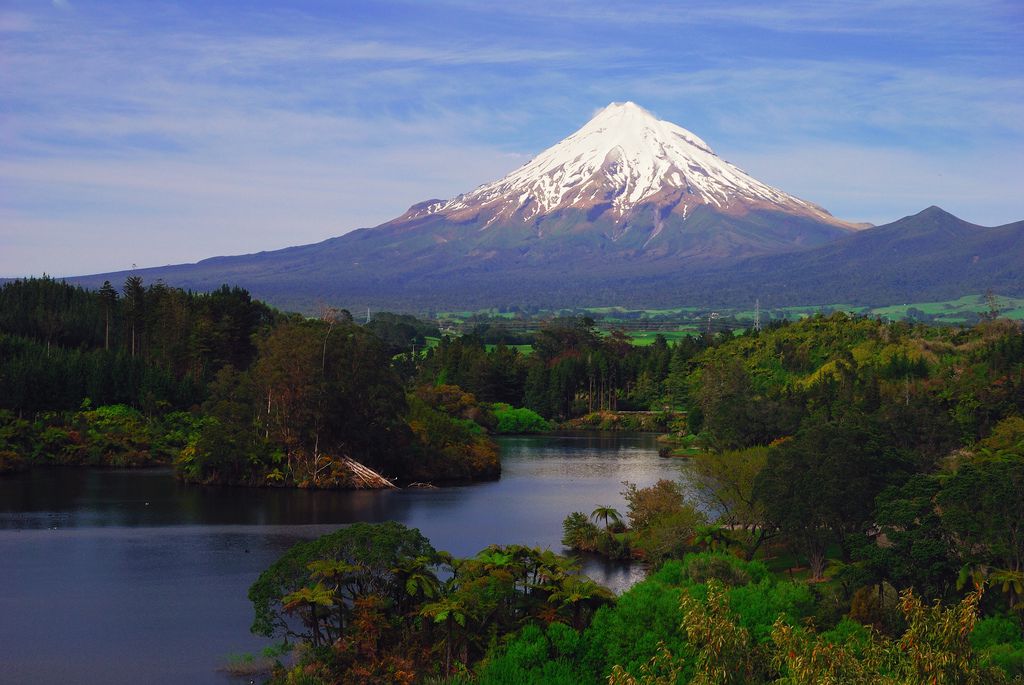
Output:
[0, 434, 679, 684]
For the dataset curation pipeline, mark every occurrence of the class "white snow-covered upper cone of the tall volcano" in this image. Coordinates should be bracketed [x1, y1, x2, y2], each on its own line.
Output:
[402, 102, 854, 228]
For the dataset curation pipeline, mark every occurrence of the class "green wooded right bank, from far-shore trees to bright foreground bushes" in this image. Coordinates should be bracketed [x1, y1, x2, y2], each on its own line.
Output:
[251, 314, 1024, 684]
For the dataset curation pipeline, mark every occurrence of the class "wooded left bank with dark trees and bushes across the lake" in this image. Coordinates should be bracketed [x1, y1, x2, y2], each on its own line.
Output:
[0, 276, 500, 487]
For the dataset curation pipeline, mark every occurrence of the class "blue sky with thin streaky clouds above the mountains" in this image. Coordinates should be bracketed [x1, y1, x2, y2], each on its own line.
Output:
[0, 0, 1024, 275]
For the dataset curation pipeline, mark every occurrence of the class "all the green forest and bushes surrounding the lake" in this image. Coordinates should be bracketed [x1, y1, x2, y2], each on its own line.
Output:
[0, 280, 1024, 685]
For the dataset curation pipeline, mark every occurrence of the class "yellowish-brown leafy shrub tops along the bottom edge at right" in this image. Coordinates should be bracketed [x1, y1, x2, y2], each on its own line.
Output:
[592, 581, 1011, 685]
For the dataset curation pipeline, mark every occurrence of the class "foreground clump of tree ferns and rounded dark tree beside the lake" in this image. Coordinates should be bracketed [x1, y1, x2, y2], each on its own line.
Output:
[243, 523, 612, 683]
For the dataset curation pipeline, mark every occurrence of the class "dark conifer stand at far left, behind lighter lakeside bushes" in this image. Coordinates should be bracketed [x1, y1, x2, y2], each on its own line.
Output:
[0, 277, 278, 415]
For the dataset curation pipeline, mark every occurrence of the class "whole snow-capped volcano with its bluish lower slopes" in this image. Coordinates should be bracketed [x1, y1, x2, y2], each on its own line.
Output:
[74, 102, 902, 308]
